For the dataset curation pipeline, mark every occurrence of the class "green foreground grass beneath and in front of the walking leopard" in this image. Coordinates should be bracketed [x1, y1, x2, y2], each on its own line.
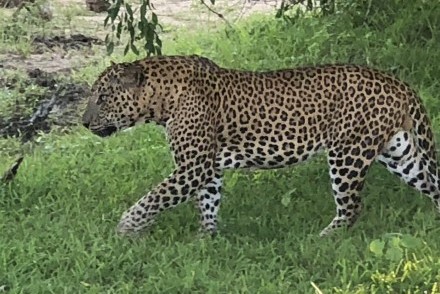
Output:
[0, 126, 440, 293]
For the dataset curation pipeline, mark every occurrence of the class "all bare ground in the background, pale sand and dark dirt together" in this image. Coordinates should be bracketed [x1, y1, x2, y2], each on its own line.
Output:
[0, 0, 278, 142]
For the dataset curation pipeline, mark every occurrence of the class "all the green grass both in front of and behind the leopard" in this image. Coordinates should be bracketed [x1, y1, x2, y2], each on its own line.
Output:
[0, 1, 440, 294]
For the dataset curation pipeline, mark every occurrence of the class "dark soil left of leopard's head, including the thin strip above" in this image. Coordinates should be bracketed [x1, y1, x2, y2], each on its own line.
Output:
[0, 34, 103, 142]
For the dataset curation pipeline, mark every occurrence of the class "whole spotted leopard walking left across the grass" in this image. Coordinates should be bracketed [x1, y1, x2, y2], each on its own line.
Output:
[82, 55, 440, 236]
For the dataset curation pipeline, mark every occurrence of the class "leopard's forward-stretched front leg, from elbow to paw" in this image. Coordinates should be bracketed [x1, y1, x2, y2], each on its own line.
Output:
[117, 162, 214, 235]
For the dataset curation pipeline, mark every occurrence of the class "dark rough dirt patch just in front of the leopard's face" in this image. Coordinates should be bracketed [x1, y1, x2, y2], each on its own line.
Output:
[0, 69, 90, 142]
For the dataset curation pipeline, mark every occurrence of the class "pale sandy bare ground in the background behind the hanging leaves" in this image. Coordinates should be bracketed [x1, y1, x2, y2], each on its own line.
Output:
[0, 0, 279, 72]
